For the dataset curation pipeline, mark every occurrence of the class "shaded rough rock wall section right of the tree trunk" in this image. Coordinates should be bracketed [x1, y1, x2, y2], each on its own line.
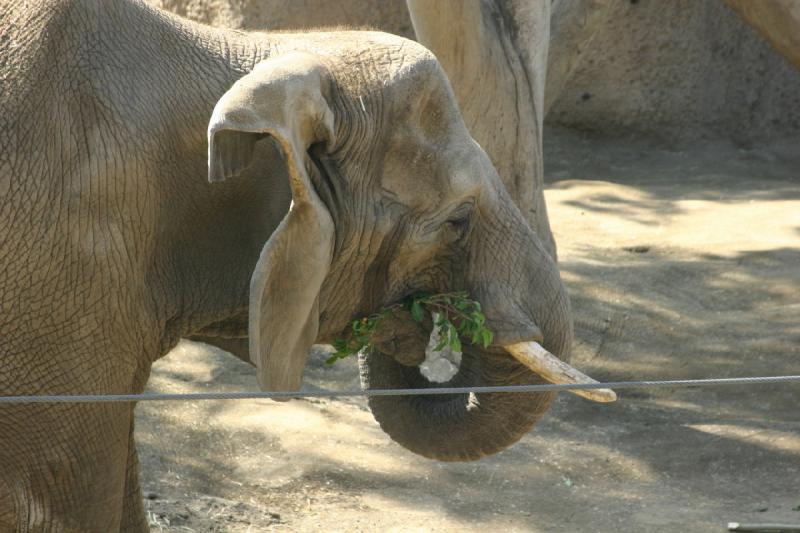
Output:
[547, 0, 800, 144]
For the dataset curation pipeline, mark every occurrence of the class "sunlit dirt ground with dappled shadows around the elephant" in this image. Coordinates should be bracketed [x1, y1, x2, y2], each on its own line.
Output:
[136, 132, 800, 533]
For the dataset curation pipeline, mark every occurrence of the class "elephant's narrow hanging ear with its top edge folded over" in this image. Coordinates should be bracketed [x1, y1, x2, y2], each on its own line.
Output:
[208, 53, 334, 391]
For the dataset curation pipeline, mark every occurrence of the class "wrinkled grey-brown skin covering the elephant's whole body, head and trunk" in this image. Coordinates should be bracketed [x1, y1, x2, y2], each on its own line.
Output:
[0, 0, 571, 532]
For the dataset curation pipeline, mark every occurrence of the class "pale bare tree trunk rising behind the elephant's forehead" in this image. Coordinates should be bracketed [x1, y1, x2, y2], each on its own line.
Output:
[408, 0, 556, 257]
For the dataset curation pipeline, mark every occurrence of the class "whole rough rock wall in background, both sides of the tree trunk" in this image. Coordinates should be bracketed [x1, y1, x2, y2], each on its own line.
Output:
[155, 0, 800, 144]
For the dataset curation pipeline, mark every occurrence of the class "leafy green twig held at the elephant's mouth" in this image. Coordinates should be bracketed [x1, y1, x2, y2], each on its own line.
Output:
[326, 292, 494, 364]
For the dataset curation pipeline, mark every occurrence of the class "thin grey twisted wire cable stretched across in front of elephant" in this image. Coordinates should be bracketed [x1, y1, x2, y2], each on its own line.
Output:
[0, 375, 800, 404]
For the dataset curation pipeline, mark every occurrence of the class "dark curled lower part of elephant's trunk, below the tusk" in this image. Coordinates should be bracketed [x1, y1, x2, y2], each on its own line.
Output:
[359, 346, 555, 461]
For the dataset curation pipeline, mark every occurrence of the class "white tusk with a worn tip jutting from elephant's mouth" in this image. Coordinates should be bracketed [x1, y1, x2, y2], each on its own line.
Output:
[503, 342, 617, 402]
